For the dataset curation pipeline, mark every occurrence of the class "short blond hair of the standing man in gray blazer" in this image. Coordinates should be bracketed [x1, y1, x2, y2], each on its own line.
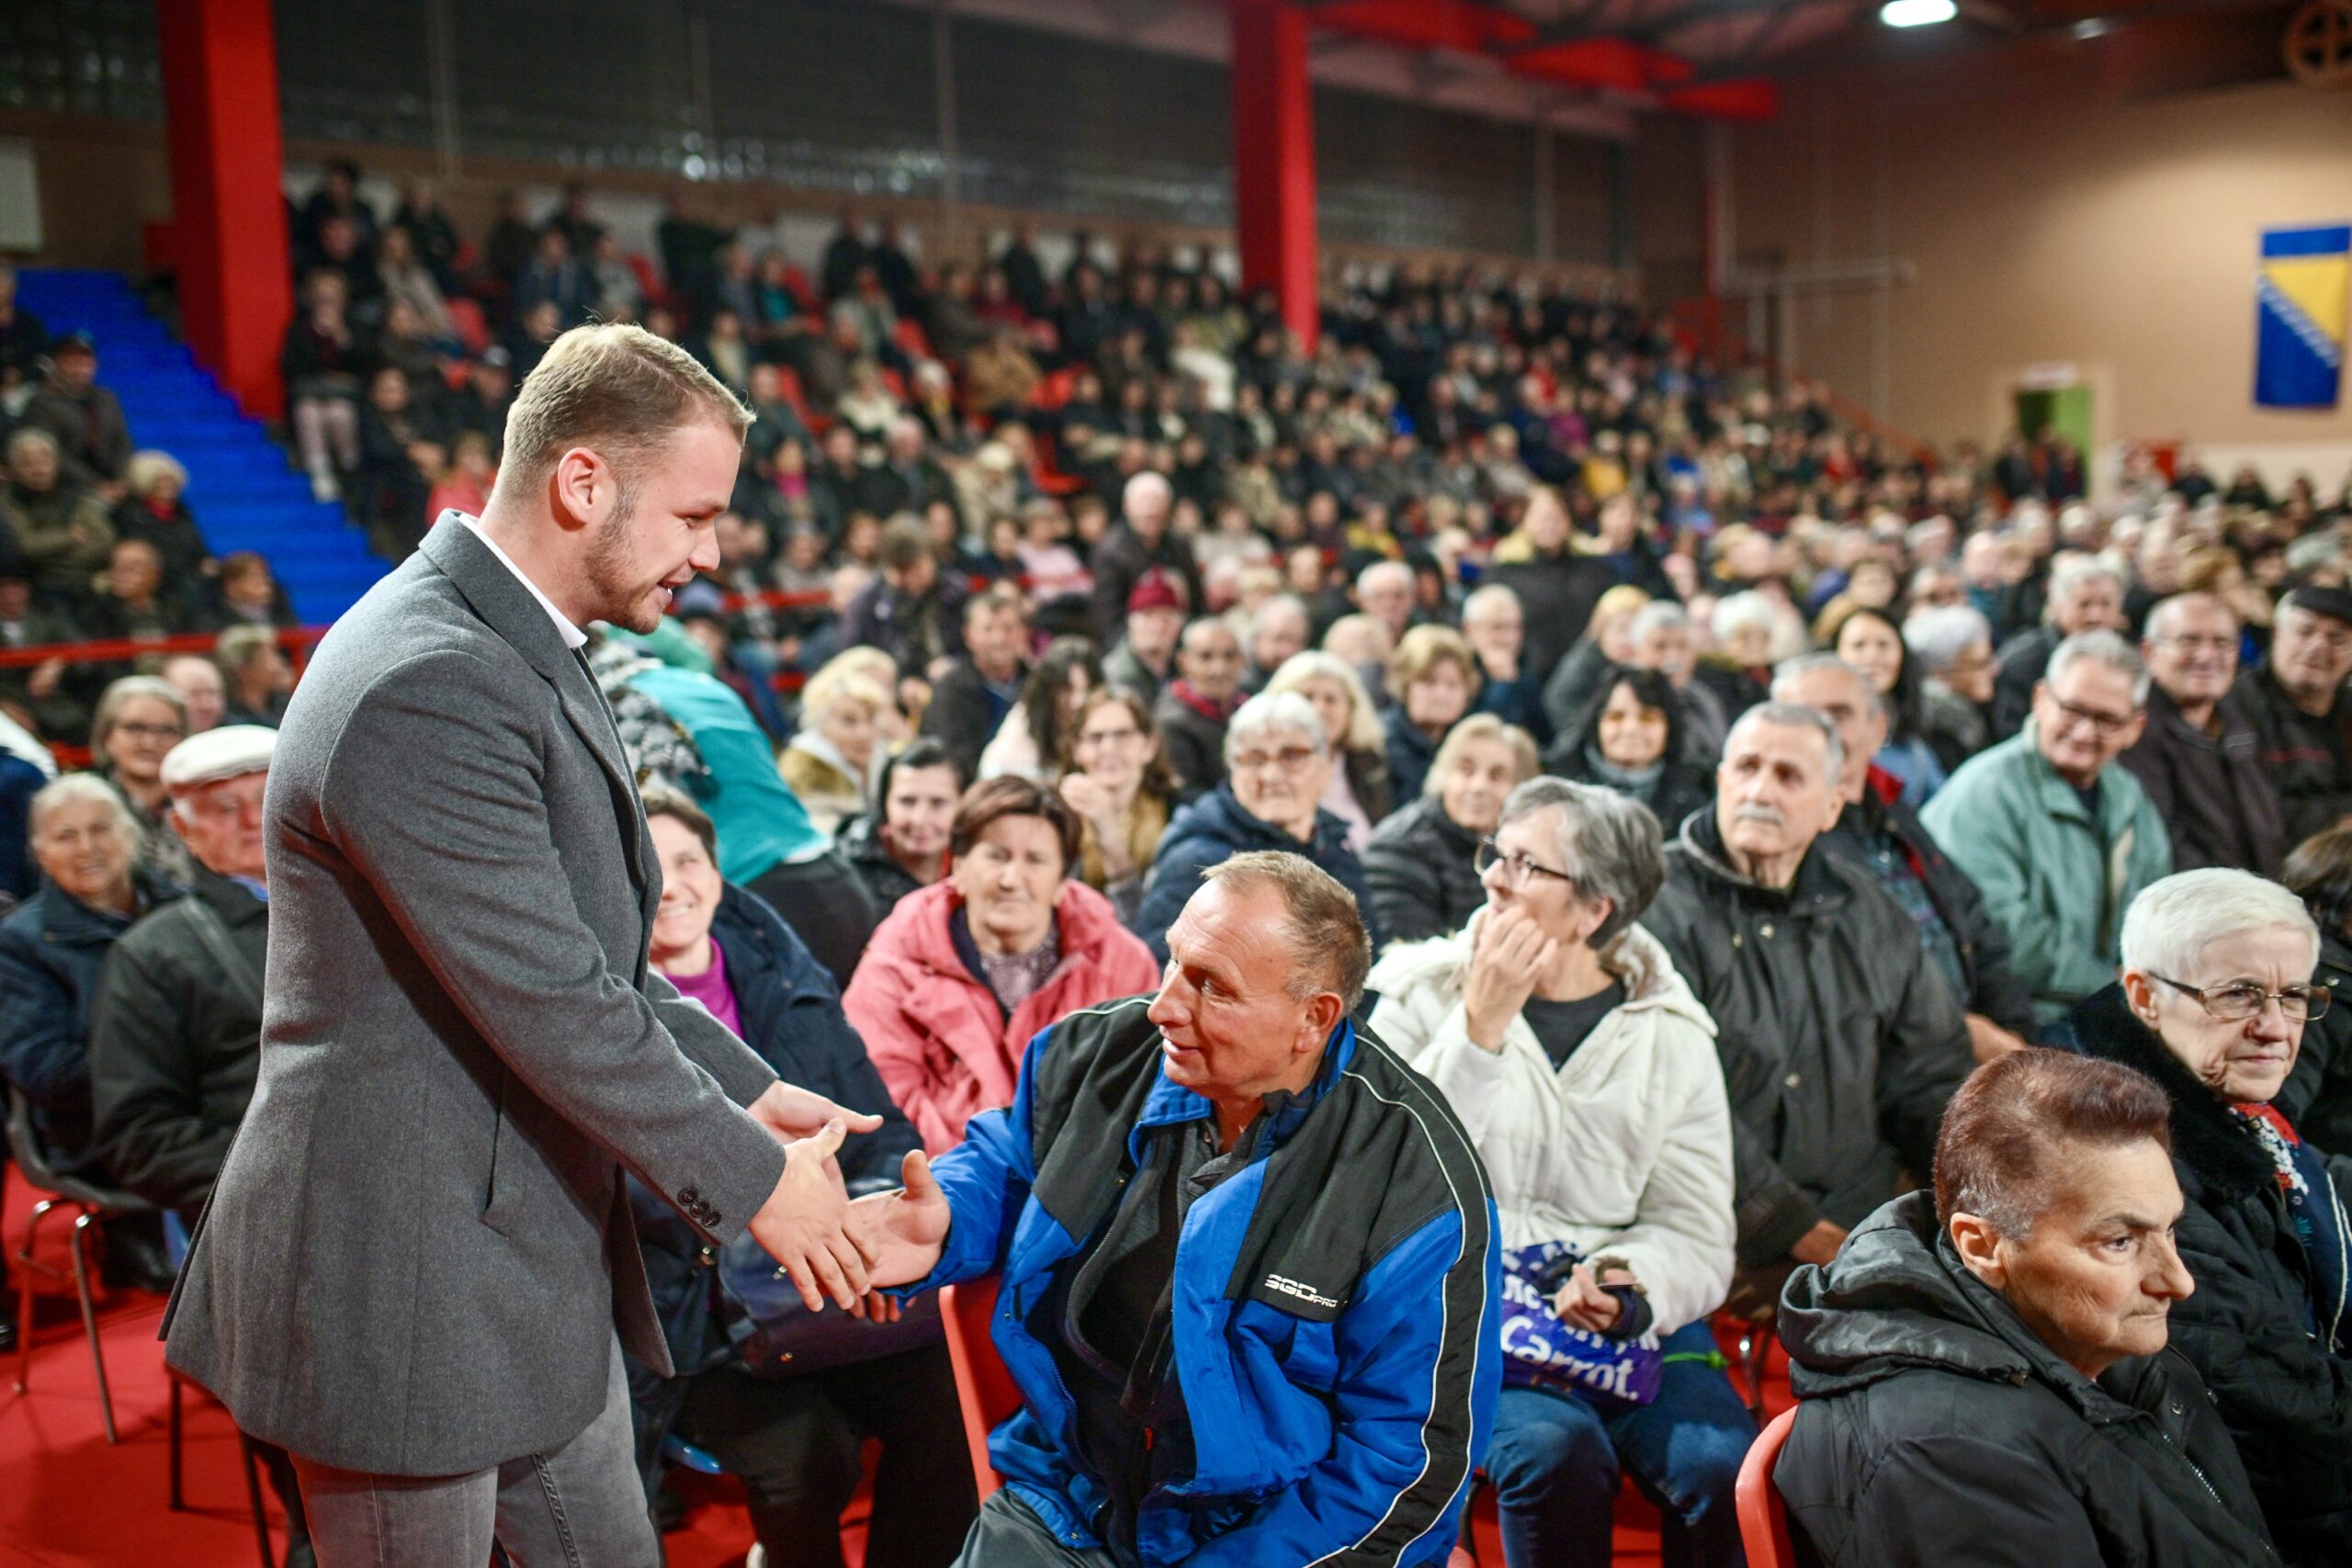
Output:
[501, 322, 752, 501]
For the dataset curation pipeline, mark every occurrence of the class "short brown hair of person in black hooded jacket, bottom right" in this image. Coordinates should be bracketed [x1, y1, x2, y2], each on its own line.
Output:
[1936, 1046, 2173, 1241]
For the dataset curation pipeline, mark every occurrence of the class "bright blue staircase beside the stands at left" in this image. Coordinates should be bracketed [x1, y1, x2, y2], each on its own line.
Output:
[17, 270, 386, 626]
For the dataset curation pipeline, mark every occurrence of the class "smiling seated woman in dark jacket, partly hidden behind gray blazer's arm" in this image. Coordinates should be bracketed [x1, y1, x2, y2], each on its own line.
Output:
[628, 790, 976, 1568]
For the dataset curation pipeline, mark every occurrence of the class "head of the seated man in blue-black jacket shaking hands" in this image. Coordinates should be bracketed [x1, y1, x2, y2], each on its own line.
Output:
[1148, 882, 1340, 1100]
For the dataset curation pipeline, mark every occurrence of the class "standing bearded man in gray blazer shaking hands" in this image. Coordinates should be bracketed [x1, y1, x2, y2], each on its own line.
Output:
[164, 327, 879, 1568]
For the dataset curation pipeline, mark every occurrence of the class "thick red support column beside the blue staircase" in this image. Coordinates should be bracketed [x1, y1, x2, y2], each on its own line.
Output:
[155, 0, 294, 416]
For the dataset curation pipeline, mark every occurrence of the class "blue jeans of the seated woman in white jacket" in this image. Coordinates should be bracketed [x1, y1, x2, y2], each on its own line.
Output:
[1487, 1321, 1757, 1568]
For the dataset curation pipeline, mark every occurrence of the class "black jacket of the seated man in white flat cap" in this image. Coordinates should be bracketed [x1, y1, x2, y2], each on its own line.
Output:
[89, 867, 270, 1220]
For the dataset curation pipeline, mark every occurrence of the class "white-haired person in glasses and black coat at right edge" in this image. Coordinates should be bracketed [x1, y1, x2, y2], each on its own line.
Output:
[2067, 867, 2352, 1563]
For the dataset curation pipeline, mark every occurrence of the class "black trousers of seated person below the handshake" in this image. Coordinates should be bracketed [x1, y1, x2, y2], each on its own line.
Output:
[639, 1345, 978, 1568]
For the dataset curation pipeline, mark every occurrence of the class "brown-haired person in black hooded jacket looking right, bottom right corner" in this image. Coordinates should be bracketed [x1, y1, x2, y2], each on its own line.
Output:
[1773, 1048, 2279, 1568]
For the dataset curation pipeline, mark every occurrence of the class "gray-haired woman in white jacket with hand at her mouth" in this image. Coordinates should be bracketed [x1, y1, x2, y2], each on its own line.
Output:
[1369, 778, 1755, 1568]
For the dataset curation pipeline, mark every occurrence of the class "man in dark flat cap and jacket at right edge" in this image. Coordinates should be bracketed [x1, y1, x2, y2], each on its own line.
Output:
[2234, 588, 2352, 849]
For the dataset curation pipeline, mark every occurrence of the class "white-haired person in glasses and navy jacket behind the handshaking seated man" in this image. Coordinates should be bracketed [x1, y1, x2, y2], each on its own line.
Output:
[1131, 691, 1381, 964]
